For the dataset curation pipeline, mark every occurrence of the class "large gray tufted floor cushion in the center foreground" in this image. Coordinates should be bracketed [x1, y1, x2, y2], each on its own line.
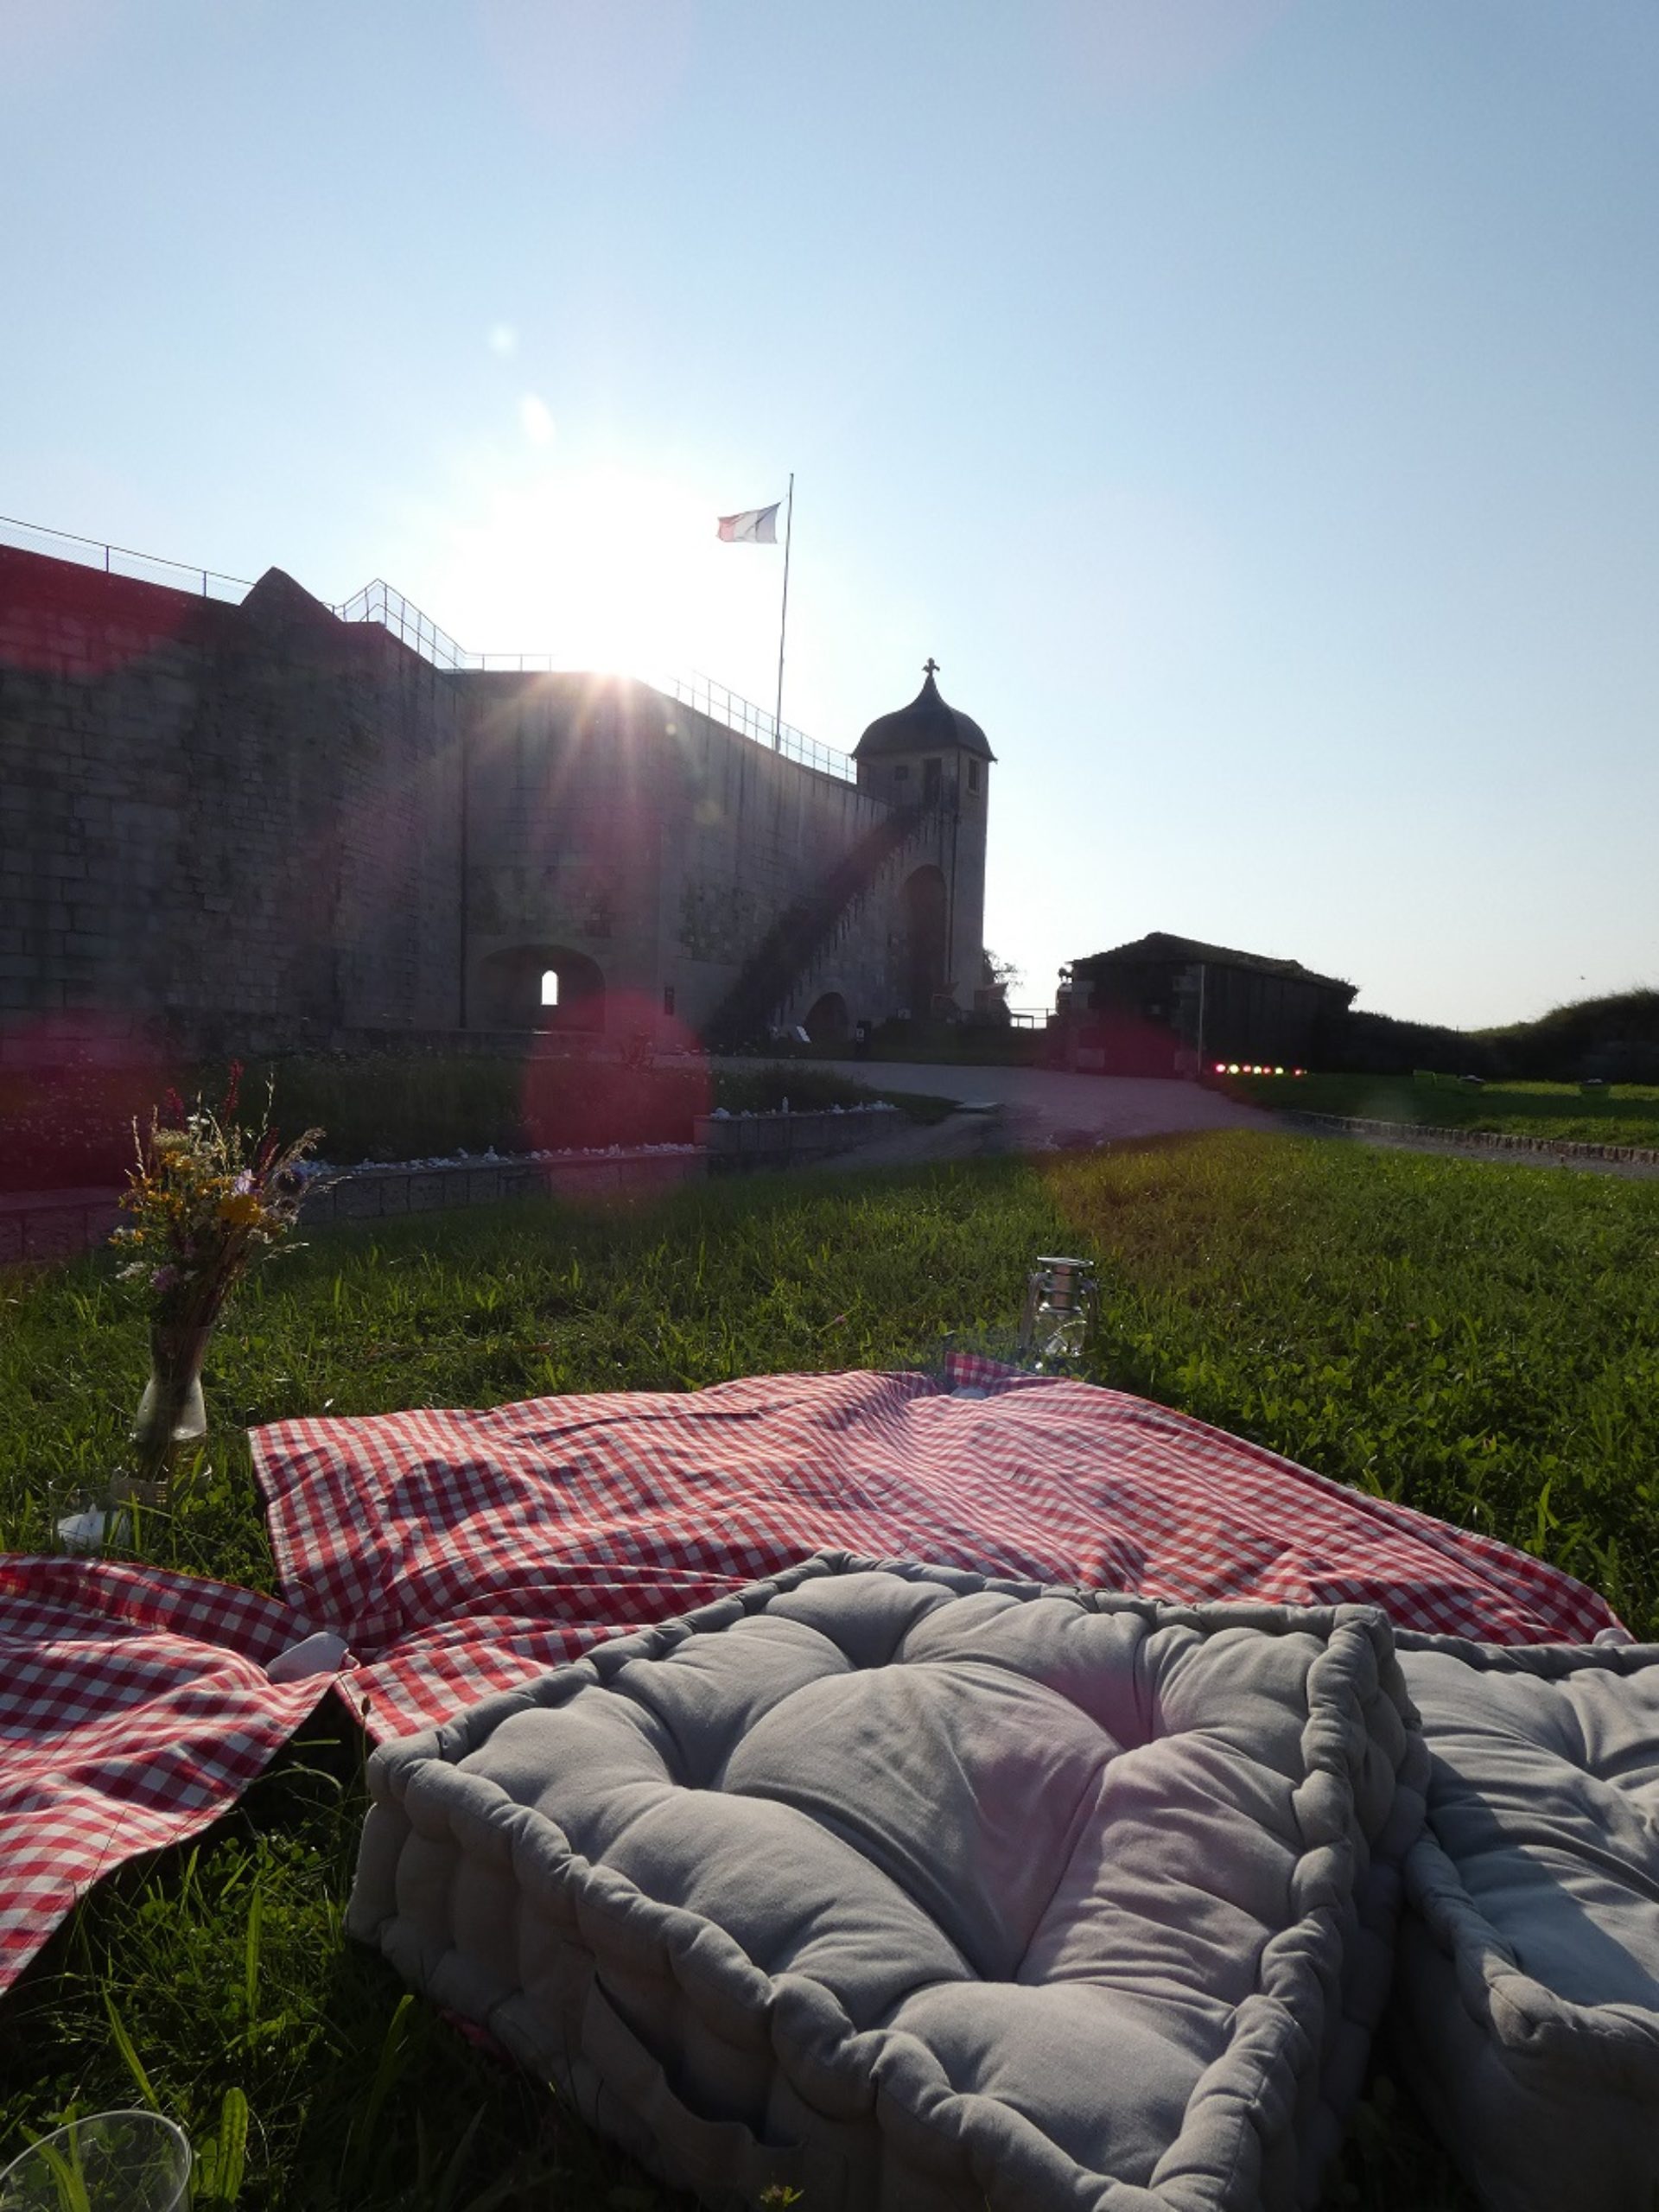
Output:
[349, 1555, 1425, 2212]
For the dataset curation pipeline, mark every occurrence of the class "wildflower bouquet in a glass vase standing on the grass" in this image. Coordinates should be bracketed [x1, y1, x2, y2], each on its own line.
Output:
[111, 1062, 323, 1504]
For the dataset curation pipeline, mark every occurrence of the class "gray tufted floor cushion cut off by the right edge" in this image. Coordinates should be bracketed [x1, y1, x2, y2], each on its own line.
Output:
[1391, 1635, 1659, 2212]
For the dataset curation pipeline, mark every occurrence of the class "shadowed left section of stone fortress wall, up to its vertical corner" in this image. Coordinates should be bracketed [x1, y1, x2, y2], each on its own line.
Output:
[0, 549, 460, 1051]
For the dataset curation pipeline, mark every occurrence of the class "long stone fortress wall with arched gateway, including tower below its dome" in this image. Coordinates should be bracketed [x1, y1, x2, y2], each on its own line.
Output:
[0, 549, 987, 1051]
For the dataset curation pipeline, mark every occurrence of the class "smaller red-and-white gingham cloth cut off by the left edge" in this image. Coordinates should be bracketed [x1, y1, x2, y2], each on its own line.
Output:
[0, 1557, 329, 1991]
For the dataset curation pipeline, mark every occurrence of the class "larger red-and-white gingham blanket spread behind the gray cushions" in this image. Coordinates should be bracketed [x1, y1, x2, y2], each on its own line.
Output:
[254, 1360, 1615, 1737]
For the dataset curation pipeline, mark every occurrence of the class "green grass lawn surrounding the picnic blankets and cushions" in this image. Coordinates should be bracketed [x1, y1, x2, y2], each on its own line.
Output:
[0, 1135, 1659, 2212]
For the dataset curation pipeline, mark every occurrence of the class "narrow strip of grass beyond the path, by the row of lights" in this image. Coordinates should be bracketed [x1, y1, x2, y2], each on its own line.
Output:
[1225, 1075, 1659, 1146]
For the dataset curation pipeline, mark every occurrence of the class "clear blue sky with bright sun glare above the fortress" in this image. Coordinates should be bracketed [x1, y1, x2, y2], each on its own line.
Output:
[0, 0, 1659, 1027]
